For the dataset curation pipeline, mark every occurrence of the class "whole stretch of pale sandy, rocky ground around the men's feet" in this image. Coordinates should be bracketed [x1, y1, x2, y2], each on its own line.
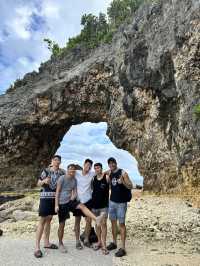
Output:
[0, 192, 200, 266]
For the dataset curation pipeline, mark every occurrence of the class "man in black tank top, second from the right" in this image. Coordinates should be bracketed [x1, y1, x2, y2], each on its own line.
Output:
[91, 163, 109, 255]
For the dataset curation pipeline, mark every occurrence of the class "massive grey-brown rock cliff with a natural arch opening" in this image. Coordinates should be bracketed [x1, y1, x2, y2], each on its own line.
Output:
[0, 0, 200, 192]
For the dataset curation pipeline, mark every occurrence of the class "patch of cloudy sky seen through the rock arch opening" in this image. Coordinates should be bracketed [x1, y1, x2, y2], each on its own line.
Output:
[57, 122, 142, 183]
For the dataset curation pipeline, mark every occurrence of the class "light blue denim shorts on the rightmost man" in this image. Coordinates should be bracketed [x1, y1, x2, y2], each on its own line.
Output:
[109, 200, 127, 224]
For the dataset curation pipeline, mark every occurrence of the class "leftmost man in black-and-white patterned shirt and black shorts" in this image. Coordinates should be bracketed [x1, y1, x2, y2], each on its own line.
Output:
[34, 155, 65, 258]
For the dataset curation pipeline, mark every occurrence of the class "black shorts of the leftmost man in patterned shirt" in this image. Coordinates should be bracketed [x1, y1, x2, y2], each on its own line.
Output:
[39, 198, 56, 217]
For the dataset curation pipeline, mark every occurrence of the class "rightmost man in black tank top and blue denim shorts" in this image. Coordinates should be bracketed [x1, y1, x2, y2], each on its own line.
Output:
[107, 157, 133, 257]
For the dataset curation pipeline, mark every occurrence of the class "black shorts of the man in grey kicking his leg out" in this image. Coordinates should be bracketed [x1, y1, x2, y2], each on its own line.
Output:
[58, 200, 80, 223]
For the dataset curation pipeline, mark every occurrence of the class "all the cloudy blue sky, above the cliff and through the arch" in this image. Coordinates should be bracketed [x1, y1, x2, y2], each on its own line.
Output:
[0, 0, 141, 185]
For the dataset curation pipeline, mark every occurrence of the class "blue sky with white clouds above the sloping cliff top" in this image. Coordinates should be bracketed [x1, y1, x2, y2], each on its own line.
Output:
[0, 0, 111, 93]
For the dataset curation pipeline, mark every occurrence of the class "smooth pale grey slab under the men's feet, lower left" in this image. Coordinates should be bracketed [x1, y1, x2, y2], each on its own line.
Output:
[0, 237, 112, 266]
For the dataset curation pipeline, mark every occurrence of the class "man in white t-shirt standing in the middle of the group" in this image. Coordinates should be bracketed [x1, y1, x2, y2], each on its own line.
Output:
[74, 159, 95, 249]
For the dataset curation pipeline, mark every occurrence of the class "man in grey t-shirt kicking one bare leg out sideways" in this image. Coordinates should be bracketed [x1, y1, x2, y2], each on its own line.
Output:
[55, 164, 103, 253]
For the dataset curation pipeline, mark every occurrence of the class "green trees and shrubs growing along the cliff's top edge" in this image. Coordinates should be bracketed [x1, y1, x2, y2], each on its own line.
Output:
[44, 0, 153, 56]
